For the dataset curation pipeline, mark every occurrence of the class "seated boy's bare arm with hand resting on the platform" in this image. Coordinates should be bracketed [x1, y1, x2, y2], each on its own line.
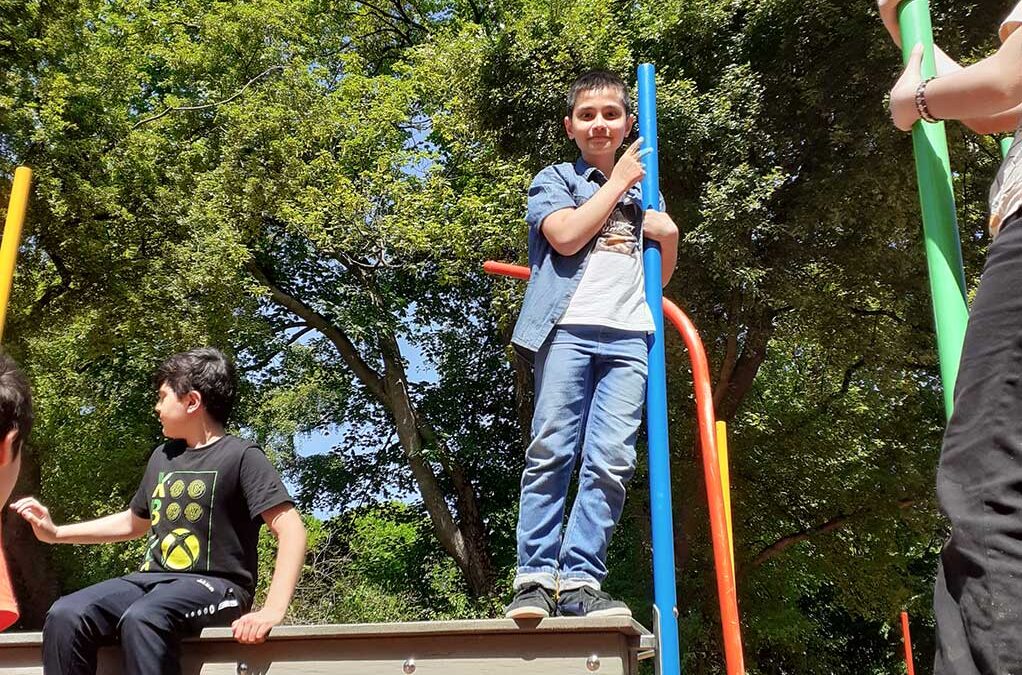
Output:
[231, 503, 306, 644]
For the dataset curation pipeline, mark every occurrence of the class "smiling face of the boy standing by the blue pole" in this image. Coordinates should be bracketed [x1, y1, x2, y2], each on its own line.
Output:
[564, 87, 635, 160]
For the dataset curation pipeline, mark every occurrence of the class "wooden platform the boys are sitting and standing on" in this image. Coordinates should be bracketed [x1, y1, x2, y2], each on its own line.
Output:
[0, 618, 654, 675]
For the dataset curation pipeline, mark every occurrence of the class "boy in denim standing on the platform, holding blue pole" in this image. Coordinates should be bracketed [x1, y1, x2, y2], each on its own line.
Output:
[506, 72, 678, 619]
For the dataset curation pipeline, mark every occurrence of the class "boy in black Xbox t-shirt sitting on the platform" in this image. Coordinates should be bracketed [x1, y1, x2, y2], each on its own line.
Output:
[11, 349, 306, 675]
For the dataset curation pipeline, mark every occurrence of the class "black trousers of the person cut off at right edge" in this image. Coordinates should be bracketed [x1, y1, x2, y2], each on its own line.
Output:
[934, 215, 1022, 675]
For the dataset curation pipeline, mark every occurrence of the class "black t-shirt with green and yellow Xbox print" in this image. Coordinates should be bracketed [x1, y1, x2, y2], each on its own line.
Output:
[131, 436, 292, 592]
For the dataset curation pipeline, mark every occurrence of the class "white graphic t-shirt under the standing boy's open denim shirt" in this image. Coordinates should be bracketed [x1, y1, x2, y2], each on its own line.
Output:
[557, 201, 655, 332]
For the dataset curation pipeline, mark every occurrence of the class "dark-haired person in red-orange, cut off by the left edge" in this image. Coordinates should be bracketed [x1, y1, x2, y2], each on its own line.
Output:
[0, 355, 33, 630]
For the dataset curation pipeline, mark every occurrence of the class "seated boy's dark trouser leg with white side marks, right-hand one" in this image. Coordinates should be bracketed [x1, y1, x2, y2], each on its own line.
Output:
[120, 573, 249, 675]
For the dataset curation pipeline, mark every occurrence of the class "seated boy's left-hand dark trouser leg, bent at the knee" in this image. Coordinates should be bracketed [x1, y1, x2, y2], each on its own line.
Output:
[43, 578, 143, 675]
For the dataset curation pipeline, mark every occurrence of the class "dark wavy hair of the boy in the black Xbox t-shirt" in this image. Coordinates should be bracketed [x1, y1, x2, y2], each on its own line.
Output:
[153, 347, 238, 424]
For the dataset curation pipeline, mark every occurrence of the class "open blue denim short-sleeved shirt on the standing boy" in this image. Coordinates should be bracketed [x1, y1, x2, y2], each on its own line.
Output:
[511, 158, 664, 357]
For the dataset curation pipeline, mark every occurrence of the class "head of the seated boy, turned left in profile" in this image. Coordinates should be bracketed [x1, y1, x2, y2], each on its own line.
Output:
[153, 347, 238, 439]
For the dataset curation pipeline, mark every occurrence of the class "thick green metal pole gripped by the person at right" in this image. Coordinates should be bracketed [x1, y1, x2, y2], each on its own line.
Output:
[898, 0, 969, 417]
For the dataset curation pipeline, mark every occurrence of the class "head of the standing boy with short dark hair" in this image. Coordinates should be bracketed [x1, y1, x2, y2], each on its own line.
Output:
[564, 71, 636, 161]
